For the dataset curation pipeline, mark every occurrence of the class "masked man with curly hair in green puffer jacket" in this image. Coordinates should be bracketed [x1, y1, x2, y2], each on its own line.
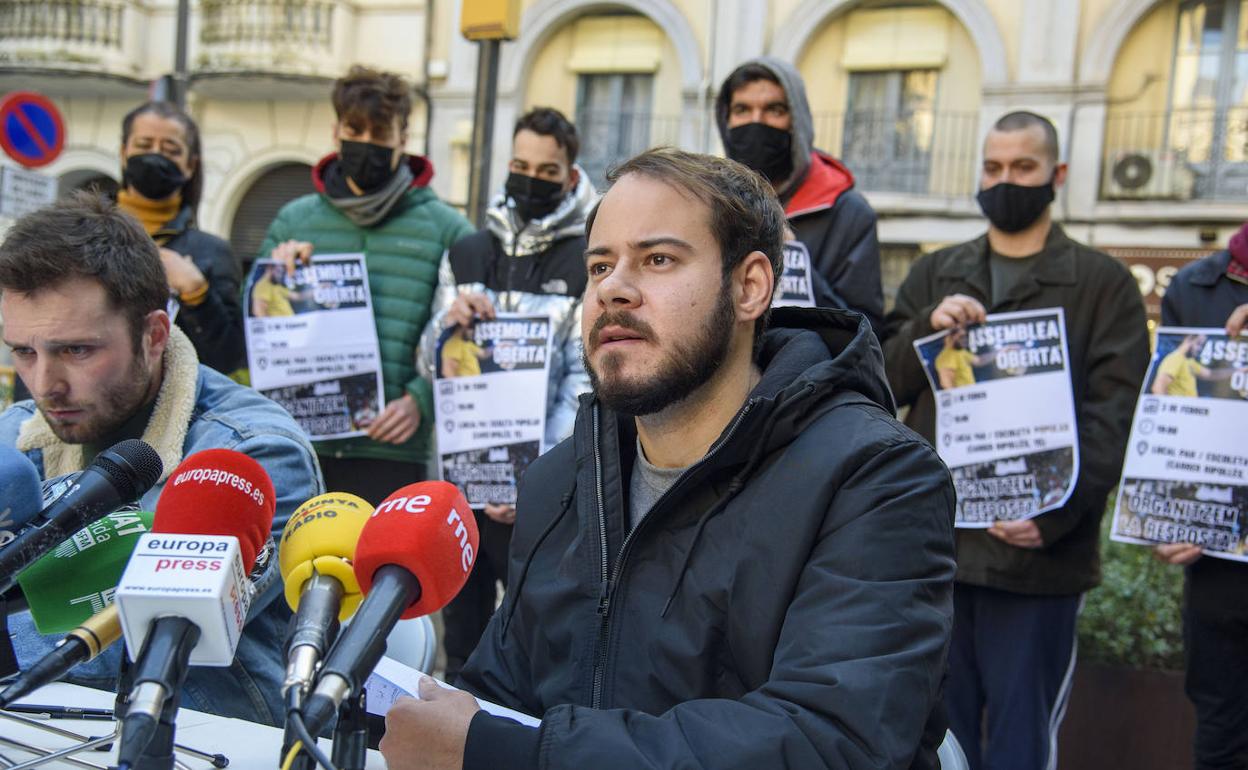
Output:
[260, 66, 473, 505]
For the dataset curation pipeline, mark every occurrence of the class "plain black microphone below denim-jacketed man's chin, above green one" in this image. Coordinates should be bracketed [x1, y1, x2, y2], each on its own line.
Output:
[0, 438, 163, 592]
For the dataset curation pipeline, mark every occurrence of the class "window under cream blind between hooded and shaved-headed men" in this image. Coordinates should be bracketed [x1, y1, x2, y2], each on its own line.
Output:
[841, 70, 938, 193]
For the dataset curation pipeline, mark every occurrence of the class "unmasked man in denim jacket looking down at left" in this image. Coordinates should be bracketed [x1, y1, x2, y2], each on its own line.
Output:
[0, 195, 324, 724]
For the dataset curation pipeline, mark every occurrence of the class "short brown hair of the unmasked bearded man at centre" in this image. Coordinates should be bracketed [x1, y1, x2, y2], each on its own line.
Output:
[585, 147, 785, 352]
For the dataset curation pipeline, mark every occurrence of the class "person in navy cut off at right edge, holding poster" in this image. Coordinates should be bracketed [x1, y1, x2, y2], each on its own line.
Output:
[1154, 225, 1248, 770]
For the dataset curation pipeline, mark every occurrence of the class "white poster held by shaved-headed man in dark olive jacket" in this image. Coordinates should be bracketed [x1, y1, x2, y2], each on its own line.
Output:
[915, 307, 1080, 528]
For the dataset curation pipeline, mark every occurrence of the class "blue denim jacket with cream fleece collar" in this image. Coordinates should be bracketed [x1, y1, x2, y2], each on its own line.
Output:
[0, 327, 324, 725]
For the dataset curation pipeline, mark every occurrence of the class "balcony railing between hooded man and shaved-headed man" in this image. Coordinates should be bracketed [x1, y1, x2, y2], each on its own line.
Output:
[814, 111, 980, 197]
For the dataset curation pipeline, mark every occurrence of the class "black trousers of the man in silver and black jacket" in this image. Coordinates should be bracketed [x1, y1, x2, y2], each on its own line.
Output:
[442, 510, 512, 683]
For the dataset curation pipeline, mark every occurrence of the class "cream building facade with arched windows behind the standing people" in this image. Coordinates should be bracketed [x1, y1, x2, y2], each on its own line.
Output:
[0, 0, 1248, 315]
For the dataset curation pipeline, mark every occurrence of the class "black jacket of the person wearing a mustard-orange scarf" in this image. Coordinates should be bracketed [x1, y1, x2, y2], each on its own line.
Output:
[152, 207, 247, 374]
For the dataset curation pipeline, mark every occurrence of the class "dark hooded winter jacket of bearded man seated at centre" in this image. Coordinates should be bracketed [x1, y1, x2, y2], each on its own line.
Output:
[459, 308, 955, 770]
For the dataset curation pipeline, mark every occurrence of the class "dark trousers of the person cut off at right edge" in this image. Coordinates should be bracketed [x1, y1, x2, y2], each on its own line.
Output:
[1183, 557, 1248, 770]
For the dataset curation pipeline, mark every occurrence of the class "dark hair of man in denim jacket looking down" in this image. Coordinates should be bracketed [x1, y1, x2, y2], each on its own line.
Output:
[0, 191, 168, 353]
